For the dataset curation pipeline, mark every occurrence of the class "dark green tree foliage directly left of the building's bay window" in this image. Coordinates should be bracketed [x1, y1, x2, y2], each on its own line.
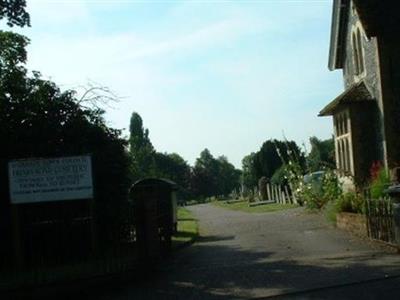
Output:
[307, 136, 335, 172]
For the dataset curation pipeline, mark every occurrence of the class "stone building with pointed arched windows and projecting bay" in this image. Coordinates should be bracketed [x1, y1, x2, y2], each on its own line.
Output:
[319, 0, 400, 186]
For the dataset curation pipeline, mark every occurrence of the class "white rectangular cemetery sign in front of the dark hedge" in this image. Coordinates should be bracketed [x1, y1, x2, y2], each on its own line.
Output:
[8, 156, 93, 204]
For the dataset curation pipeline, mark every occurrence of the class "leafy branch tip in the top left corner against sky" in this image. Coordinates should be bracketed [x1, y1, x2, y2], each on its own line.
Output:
[0, 0, 30, 27]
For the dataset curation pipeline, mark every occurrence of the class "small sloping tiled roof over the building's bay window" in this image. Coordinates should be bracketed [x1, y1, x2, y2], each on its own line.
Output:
[318, 80, 373, 117]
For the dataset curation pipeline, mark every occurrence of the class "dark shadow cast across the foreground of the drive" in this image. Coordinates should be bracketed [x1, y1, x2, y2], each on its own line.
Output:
[13, 240, 400, 300]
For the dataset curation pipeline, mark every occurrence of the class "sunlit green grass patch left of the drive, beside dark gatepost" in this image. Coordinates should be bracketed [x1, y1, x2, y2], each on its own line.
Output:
[172, 207, 199, 249]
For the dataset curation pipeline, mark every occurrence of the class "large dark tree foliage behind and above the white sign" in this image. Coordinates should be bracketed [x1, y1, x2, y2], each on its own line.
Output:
[0, 31, 130, 234]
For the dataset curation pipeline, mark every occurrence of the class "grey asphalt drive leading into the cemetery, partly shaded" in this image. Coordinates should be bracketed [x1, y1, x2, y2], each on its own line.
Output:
[20, 205, 400, 300]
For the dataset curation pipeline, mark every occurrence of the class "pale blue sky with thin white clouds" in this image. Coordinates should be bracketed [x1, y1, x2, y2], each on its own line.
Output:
[3, 0, 343, 167]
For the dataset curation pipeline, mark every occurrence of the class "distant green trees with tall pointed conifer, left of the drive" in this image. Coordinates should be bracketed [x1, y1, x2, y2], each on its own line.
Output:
[129, 112, 241, 199]
